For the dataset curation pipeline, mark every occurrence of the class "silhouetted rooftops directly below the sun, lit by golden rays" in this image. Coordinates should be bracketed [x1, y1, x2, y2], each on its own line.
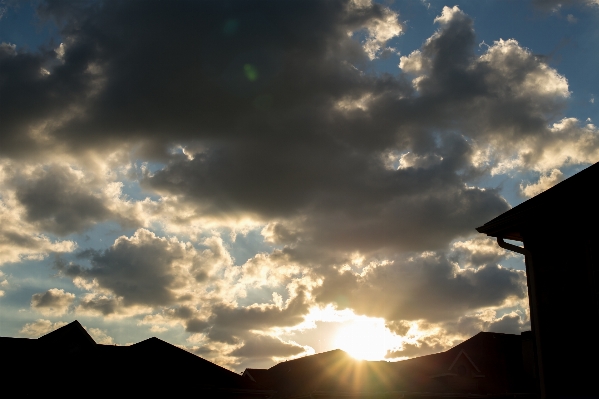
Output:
[243, 332, 537, 399]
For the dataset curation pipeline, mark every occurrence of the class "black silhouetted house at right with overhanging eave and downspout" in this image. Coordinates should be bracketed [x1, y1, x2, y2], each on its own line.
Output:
[477, 163, 599, 398]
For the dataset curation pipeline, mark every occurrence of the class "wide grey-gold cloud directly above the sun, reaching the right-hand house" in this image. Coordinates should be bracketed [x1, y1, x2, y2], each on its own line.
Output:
[314, 253, 527, 322]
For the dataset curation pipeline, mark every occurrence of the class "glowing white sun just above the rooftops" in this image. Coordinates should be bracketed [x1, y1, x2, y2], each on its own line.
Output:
[333, 317, 398, 360]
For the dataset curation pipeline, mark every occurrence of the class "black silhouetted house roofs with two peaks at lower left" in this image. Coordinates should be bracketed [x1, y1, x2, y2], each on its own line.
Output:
[0, 321, 274, 399]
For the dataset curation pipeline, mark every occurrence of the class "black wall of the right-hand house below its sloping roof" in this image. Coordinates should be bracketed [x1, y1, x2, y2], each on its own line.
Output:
[524, 233, 599, 398]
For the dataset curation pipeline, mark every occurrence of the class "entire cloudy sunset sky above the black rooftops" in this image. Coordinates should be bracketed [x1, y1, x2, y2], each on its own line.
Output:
[0, 0, 599, 372]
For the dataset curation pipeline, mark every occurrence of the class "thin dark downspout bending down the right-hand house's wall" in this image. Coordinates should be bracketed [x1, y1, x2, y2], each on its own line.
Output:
[497, 237, 547, 399]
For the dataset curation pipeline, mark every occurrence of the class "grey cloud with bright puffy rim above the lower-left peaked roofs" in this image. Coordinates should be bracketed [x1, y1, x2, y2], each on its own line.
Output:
[57, 229, 213, 313]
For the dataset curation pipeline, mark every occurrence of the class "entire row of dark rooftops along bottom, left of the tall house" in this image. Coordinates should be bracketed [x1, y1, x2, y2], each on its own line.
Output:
[0, 321, 536, 399]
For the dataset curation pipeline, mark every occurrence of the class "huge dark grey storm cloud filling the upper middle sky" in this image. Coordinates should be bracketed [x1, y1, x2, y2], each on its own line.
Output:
[5, 1, 572, 251]
